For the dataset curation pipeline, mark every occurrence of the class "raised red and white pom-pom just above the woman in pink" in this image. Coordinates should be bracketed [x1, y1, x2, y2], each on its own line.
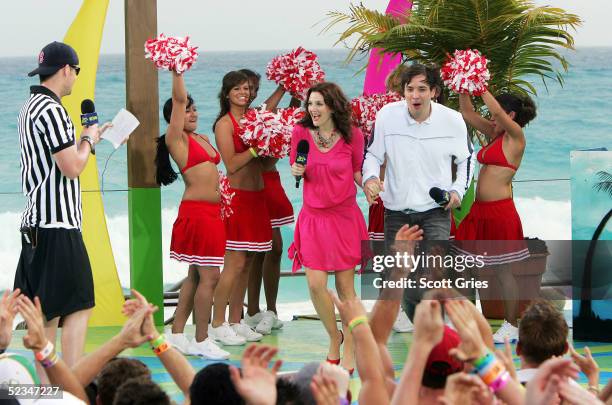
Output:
[266, 46, 325, 100]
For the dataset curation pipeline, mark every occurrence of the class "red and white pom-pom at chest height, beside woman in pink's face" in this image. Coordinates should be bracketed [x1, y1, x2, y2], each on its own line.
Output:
[238, 105, 304, 159]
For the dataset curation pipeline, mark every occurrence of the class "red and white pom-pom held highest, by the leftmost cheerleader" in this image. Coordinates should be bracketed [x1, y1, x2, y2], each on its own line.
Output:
[145, 34, 198, 74]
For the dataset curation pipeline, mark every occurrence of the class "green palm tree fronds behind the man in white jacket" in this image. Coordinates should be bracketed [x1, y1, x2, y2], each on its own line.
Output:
[324, 0, 581, 106]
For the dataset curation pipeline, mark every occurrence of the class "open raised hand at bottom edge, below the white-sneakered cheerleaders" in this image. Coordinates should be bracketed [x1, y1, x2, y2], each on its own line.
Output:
[230, 344, 282, 405]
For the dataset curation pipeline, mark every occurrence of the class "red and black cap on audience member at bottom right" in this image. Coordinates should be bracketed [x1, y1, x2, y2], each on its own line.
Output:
[423, 325, 463, 388]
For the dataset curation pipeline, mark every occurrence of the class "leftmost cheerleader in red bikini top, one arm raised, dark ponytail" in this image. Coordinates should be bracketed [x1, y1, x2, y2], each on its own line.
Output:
[155, 73, 229, 360]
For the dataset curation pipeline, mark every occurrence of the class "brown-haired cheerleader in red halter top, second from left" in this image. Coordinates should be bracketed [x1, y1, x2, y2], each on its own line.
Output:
[209, 71, 272, 345]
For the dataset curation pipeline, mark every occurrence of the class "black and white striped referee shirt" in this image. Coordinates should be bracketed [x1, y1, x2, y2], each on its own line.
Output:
[18, 86, 82, 229]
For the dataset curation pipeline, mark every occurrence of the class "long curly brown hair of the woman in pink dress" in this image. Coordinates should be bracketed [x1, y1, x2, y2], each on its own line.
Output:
[300, 82, 353, 143]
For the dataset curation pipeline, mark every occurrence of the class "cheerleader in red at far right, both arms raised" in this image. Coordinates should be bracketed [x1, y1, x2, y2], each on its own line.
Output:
[455, 91, 536, 343]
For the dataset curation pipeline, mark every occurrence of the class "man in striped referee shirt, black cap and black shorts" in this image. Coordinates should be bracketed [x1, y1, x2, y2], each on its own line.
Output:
[14, 42, 107, 366]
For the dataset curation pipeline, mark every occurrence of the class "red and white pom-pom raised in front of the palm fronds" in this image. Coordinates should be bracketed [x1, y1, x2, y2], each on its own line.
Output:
[441, 49, 491, 96]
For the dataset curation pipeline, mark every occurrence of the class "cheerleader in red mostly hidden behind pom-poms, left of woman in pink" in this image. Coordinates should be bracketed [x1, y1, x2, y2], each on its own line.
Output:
[240, 69, 300, 335]
